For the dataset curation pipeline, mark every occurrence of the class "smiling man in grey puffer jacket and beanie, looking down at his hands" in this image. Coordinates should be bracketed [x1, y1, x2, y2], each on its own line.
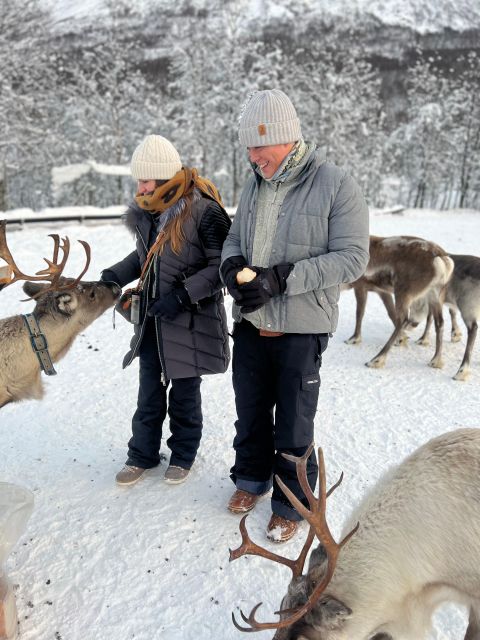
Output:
[221, 89, 369, 542]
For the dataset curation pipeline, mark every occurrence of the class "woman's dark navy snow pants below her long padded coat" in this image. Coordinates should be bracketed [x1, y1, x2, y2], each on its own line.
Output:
[127, 322, 203, 469]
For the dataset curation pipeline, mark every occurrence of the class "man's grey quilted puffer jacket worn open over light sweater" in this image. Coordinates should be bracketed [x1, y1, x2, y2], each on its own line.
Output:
[222, 151, 369, 333]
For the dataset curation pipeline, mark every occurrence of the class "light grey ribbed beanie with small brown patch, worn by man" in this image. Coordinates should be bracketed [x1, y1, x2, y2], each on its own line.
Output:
[238, 89, 302, 147]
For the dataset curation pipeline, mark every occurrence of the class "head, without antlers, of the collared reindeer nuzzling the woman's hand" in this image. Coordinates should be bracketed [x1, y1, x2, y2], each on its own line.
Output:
[23, 277, 121, 327]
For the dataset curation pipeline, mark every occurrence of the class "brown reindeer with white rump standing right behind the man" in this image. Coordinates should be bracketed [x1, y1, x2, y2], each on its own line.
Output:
[347, 236, 453, 368]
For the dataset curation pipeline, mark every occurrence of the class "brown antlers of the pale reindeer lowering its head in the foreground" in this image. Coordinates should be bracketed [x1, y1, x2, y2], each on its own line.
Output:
[230, 444, 359, 632]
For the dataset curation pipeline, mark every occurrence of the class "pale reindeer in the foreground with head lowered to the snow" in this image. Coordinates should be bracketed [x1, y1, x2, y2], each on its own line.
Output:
[230, 429, 480, 640]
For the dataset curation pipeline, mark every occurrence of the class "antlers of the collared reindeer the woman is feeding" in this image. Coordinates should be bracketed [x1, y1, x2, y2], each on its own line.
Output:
[0, 220, 90, 291]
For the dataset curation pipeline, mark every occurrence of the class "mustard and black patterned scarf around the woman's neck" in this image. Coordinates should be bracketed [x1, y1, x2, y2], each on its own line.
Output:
[135, 167, 223, 213]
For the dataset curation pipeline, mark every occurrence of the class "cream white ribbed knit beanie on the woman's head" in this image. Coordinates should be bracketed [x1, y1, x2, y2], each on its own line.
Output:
[130, 135, 182, 180]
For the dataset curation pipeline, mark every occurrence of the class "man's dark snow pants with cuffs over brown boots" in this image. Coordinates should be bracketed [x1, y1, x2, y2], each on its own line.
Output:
[231, 320, 328, 520]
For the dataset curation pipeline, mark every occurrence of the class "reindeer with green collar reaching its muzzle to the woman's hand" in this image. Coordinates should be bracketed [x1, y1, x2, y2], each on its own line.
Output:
[0, 225, 121, 408]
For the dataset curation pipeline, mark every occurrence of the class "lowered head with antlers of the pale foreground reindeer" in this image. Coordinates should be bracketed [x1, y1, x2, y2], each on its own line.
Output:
[230, 444, 358, 640]
